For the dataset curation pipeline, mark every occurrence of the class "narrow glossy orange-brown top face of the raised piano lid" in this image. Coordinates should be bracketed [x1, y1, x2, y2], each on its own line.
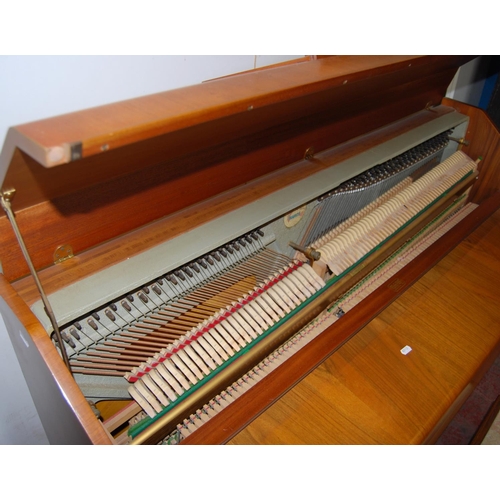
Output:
[0, 56, 463, 167]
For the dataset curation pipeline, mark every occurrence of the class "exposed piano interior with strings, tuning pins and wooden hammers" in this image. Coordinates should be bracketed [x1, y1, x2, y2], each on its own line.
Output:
[46, 130, 475, 443]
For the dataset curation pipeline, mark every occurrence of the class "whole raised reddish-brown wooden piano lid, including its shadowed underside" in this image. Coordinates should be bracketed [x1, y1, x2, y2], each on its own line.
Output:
[0, 56, 471, 281]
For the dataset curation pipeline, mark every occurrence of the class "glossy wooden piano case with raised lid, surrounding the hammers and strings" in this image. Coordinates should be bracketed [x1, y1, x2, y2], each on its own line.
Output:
[0, 56, 500, 444]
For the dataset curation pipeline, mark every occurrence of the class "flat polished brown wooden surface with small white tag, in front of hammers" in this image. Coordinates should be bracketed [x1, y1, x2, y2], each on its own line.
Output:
[230, 207, 500, 444]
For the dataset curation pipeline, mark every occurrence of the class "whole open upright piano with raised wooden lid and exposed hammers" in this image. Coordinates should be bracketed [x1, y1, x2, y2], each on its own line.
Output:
[0, 56, 500, 445]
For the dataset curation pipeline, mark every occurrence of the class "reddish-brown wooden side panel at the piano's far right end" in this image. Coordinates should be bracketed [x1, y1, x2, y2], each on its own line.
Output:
[443, 99, 500, 203]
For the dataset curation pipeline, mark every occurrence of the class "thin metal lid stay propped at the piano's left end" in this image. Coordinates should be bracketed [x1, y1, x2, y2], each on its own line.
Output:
[0, 189, 73, 374]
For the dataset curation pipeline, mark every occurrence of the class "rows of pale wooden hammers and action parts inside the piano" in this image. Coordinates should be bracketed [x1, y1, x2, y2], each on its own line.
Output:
[110, 152, 476, 443]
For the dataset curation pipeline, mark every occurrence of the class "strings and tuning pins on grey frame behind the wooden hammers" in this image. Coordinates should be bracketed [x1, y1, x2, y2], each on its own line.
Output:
[54, 130, 458, 394]
